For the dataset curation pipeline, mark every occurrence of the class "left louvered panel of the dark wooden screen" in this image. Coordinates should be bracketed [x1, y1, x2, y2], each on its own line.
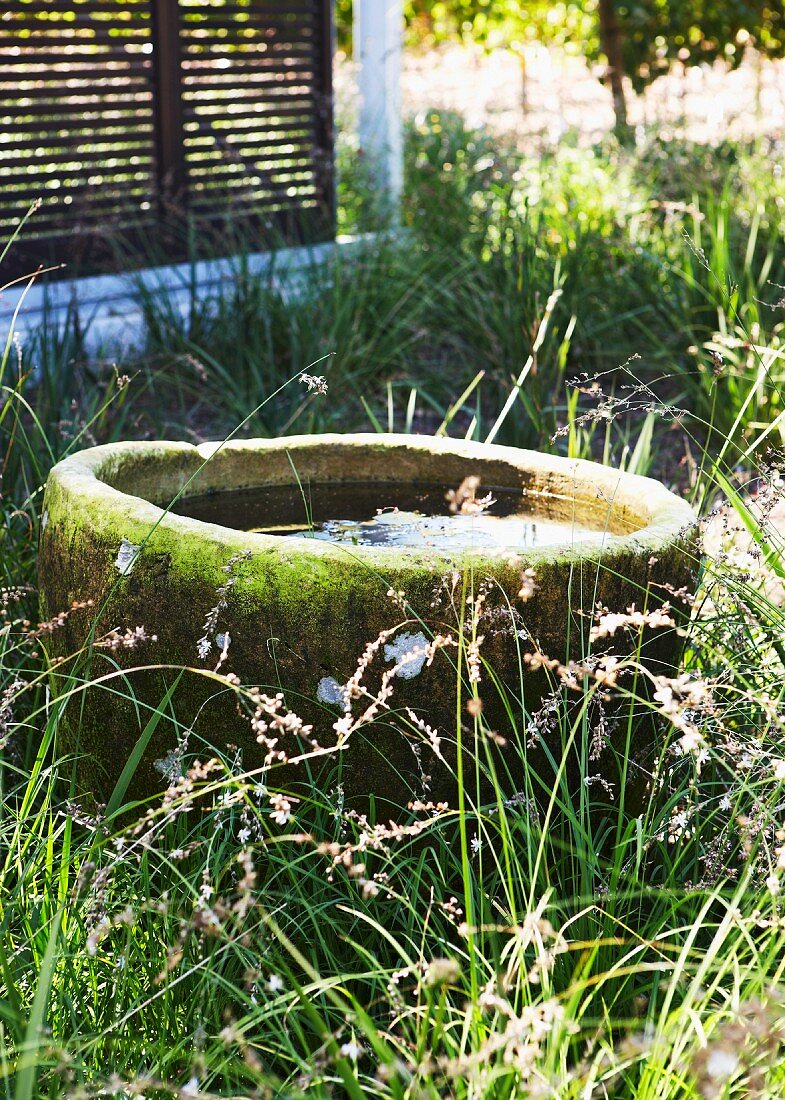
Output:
[0, 0, 156, 278]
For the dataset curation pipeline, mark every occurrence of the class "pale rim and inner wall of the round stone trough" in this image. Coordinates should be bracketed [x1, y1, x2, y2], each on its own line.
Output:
[42, 432, 696, 573]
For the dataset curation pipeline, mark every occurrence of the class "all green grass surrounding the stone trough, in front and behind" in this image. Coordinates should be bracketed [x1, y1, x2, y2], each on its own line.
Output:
[7, 120, 785, 1100]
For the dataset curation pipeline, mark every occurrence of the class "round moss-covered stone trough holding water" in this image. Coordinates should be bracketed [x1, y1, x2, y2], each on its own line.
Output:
[40, 435, 696, 805]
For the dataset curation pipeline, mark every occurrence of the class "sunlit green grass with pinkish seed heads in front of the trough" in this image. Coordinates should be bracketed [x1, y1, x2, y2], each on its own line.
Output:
[0, 323, 785, 1100]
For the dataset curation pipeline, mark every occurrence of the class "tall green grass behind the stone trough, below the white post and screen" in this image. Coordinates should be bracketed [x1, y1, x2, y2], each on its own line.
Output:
[88, 112, 785, 468]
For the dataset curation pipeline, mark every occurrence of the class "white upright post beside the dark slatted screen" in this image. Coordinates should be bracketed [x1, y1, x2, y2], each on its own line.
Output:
[354, 0, 403, 218]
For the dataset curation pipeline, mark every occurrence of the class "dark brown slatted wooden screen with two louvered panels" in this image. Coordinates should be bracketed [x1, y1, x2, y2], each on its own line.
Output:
[0, 0, 334, 283]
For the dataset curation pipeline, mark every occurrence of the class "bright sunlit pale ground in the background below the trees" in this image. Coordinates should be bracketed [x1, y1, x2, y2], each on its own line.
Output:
[336, 46, 785, 149]
